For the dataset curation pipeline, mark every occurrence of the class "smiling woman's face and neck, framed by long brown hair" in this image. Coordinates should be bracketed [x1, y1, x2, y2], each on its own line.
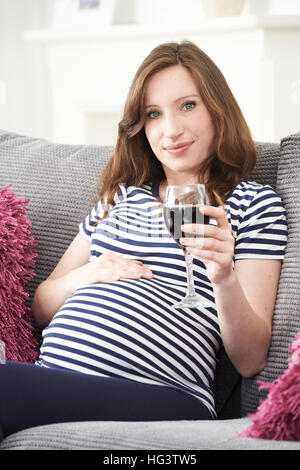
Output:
[145, 65, 215, 184]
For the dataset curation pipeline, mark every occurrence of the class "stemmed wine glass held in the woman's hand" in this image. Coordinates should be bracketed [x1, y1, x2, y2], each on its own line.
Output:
[163, 184, 212, 308]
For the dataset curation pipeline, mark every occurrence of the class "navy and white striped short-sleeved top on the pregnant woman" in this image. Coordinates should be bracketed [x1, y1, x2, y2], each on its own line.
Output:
[38, 180, 287, 416]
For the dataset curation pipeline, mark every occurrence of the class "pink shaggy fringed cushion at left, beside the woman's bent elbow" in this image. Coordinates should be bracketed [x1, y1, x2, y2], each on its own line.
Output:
[0, 186, 38, 362]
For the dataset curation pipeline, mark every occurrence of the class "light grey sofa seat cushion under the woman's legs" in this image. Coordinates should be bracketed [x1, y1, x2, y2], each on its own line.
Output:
[0, 418, 300, 452]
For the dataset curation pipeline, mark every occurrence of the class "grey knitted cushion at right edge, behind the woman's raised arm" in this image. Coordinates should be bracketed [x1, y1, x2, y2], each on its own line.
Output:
[242, 133, 300, 414]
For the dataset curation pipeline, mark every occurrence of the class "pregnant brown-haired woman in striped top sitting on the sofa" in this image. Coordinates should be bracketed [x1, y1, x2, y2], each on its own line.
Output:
[0, 42, 286, 439]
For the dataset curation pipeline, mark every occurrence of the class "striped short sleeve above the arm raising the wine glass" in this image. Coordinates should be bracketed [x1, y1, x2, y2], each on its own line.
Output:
[234, 185, 287, 260]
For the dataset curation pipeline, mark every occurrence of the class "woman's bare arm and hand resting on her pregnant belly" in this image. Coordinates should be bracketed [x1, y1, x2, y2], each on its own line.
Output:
[32, 233, 153, 326]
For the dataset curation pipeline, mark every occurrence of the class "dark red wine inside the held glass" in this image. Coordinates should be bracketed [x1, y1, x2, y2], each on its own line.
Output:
[164, 205, 209, 243]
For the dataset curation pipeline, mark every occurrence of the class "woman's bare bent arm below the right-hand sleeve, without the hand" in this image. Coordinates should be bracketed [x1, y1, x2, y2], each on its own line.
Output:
[213, 255, 281, 377]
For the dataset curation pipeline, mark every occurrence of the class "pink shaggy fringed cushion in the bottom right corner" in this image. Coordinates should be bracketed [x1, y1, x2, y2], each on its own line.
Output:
[240, 332, 300, 441]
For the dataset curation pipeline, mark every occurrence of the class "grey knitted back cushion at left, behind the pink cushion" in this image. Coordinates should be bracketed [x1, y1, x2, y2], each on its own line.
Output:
[0, 131, 112, 301]
